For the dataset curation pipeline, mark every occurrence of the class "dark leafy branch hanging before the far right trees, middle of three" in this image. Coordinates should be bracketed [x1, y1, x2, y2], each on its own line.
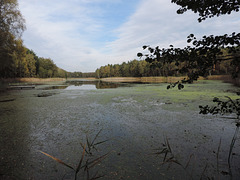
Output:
[137, 33, 240, 89]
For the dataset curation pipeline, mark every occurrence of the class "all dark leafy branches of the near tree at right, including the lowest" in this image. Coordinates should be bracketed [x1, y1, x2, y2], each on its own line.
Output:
[138, 0, 240, 179]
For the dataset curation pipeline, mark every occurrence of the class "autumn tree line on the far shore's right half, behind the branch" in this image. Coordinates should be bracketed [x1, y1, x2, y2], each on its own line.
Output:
[95, 50, 234, 78]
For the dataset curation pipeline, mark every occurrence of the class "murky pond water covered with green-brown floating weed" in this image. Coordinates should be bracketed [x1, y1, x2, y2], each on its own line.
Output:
[0, 81, 240, 180]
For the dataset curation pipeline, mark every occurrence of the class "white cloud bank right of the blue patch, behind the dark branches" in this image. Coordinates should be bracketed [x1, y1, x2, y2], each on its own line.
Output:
[108, 0, 240, 64]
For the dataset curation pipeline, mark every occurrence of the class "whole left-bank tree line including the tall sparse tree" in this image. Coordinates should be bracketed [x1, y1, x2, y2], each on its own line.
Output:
[0, 0, 95, 78]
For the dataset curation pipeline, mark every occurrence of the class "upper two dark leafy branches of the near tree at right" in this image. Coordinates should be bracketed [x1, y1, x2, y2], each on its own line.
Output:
[137, 0, 240, 89]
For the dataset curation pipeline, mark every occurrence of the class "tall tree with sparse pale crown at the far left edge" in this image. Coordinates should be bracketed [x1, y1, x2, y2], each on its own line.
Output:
[0, 0, 25, 77]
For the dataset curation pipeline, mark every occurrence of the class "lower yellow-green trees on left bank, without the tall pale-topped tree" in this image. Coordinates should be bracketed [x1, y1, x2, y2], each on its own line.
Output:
[0, 43, 95, 78]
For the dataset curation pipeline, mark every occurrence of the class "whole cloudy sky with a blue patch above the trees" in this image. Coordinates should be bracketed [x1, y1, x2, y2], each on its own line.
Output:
[19, 0, 240, 72]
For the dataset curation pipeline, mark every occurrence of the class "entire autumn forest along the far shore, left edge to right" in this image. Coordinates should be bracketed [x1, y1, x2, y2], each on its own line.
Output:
[0, 0, 240, 78]
